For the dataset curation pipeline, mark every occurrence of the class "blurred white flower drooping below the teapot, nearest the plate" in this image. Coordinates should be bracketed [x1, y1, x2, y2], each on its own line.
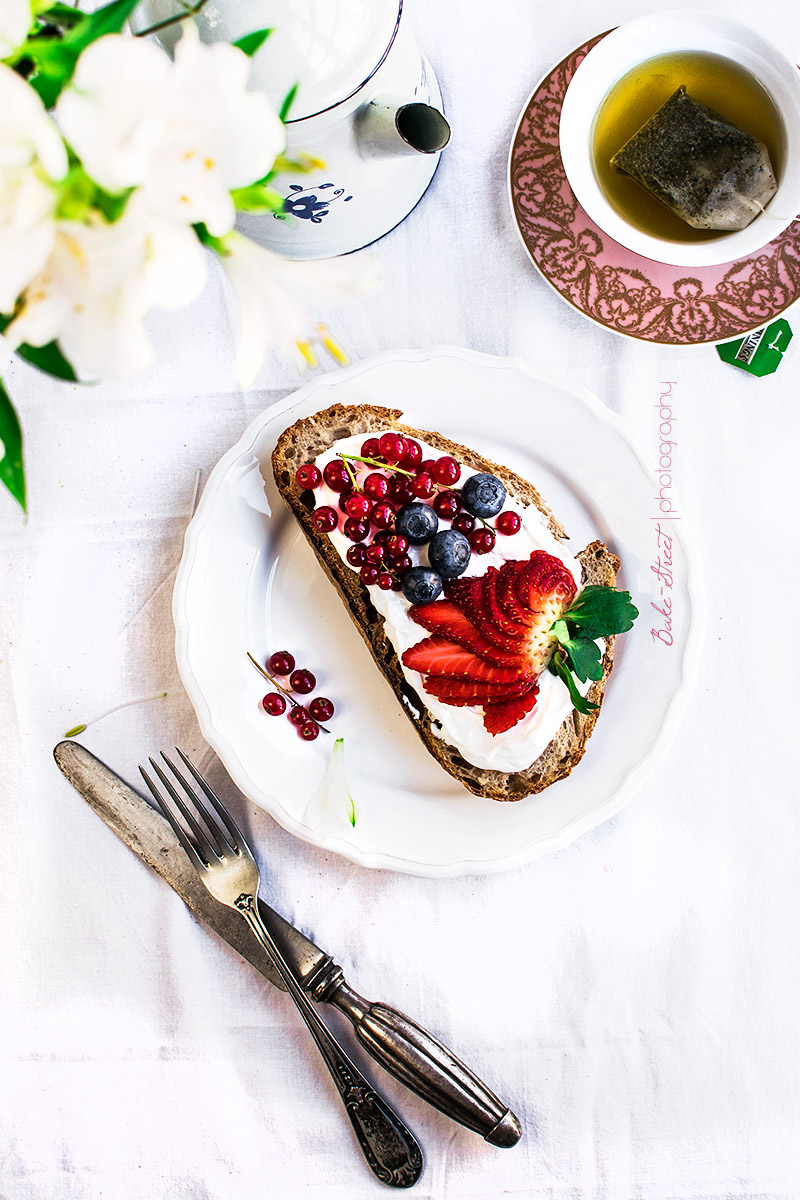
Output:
[221, 233, 378, 388]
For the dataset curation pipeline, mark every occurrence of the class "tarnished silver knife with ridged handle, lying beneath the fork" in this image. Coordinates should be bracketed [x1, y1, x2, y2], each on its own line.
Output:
[53, 742, 522, 1146]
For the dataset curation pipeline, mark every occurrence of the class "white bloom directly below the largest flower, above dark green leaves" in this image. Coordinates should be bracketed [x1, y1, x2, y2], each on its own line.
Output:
[6, 196, 206, 379]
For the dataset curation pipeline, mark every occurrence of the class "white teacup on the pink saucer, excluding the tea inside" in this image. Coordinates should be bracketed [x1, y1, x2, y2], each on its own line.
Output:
[559, 10, 800, 266]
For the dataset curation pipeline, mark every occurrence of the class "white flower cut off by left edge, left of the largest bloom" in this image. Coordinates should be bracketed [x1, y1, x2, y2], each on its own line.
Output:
[0, 63, 67, 313]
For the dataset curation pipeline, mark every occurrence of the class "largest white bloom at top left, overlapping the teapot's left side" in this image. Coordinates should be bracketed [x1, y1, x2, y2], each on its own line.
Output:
[56, 23, 285, 236]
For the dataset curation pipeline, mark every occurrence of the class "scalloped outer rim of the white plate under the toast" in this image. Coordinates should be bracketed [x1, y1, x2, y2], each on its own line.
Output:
[173, 346, 705, 878]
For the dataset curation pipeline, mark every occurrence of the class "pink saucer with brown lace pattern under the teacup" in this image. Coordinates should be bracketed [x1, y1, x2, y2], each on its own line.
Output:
[509, 34, 800, 346]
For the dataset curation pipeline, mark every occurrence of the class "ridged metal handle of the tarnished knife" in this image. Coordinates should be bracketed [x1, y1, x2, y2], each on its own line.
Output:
[320, 974, 522, 1146]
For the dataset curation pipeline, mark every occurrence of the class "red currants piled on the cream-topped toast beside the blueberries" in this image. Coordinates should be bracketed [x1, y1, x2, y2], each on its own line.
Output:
[295, 431, 522, 592]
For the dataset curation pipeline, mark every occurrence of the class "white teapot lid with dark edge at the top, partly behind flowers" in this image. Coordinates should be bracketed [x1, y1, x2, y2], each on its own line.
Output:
[196, 0, 403, 121]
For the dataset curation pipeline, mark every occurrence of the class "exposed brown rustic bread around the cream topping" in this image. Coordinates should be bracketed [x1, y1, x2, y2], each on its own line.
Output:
[272, 404, 619, 800]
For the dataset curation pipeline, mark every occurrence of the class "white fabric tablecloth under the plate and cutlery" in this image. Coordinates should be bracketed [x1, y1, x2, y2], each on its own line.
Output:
[0, 0, 800, 1200]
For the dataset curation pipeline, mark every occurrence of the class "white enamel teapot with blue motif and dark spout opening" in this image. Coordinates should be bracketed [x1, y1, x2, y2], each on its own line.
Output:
[144, 0, 450, 258]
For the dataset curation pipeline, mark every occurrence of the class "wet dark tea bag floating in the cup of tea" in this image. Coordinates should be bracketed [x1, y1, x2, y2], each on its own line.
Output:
[612, 86, 777, 230]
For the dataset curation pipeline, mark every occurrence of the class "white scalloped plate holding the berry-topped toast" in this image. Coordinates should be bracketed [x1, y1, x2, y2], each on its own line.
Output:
[174, 349, 700, 876]
